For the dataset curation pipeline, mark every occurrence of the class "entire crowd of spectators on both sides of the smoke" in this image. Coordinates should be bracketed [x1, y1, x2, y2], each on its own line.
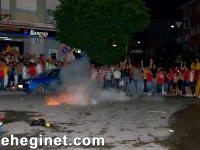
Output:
[0, 48, 200, 98]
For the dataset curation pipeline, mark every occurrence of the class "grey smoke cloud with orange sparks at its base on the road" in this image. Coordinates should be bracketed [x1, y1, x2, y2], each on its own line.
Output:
[47, 53, 129, 105]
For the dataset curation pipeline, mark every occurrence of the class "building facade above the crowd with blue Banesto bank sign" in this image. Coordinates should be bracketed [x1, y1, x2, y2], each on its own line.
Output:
[0, 0, 63, 59]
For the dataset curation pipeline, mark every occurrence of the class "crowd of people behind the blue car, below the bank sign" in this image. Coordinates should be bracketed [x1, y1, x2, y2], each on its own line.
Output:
[0, 50, 63, 91]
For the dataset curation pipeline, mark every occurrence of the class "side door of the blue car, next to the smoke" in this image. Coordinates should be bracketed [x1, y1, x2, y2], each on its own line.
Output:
[47, 69, 61, 91]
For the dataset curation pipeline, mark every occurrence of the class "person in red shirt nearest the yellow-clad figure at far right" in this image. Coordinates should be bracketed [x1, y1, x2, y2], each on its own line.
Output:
[183, 67, 190, 96]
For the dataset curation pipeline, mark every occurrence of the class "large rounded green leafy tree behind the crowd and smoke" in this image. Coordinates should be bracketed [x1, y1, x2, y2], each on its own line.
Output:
[54, 0, 150, 63]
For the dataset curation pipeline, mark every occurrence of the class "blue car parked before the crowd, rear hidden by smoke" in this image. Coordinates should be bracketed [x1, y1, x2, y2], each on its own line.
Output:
[18, 69, 61, 95]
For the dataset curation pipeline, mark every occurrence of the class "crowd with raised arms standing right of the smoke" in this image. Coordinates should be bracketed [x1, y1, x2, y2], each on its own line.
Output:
[91, 59, 200, 98]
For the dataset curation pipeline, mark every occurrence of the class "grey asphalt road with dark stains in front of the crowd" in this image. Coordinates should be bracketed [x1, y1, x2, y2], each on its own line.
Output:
[0, 93, 200, 150]
